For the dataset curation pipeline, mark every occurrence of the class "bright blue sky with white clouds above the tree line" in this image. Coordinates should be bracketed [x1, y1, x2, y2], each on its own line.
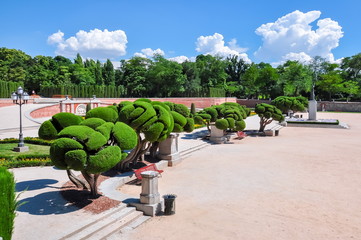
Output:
[0, 0, 361, 65]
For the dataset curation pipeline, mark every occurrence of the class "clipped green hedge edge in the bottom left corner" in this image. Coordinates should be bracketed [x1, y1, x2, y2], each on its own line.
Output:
[0, 167, 18, 240]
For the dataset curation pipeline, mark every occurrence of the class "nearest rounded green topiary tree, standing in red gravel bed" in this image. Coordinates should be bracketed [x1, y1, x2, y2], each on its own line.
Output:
[50, 120, 137, 196]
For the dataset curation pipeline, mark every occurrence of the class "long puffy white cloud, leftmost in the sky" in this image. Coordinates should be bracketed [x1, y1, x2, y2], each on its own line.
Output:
[48, 29, 128, 60]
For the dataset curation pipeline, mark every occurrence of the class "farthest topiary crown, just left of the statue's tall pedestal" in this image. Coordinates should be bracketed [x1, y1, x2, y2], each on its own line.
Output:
[272, 96, 308, 114]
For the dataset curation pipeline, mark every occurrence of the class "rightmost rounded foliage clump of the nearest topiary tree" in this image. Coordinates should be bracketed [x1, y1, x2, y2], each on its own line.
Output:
[112, 122, 138, 150]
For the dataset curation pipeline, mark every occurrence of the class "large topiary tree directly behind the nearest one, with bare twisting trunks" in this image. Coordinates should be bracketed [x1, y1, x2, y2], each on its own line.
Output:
[117, 98, 194, 170]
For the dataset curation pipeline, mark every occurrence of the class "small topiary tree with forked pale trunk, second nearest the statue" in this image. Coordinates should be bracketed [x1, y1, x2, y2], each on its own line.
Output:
[255, 103, 285, 132]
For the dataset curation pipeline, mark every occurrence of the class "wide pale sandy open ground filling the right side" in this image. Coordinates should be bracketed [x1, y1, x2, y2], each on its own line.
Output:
[119, 113, 361, 240]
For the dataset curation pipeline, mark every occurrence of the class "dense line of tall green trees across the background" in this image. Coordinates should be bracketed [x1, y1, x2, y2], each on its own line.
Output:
[0, 48, 361, 100]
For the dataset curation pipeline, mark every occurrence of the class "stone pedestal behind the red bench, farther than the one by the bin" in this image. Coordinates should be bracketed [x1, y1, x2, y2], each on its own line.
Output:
[157, 133, 181, 167]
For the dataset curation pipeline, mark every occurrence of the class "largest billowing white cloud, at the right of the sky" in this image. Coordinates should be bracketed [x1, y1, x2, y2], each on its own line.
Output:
[255, 10, 343, 62]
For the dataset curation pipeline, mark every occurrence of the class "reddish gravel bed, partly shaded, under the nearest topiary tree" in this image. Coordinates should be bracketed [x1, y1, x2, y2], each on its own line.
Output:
[61, 172, 120, 214]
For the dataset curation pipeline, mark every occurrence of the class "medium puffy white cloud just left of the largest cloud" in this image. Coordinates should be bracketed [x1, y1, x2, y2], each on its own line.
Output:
[196, 33, 251, 62]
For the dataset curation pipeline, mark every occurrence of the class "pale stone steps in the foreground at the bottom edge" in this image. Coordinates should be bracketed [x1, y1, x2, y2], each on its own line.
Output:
[61, 204, 143, 240]
